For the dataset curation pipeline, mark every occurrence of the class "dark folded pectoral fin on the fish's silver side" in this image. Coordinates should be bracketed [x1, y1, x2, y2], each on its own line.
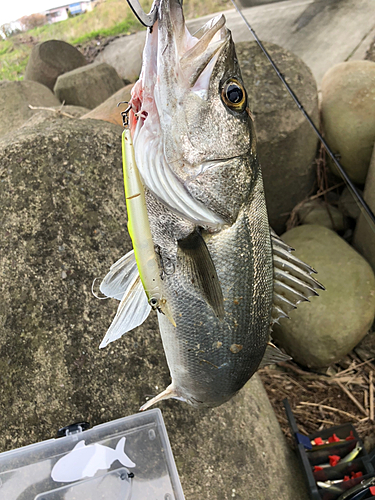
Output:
[178, 231, 224, 320]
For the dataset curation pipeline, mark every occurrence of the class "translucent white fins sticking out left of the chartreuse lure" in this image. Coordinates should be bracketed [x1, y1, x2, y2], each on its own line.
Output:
[99, 252, 151, 348]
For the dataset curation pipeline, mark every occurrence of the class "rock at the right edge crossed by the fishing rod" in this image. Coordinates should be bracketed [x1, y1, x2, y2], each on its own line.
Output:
[353, 144, 375, 272]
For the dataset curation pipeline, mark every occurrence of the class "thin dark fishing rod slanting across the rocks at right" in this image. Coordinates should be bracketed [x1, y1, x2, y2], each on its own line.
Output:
[231, 0, 375, 233]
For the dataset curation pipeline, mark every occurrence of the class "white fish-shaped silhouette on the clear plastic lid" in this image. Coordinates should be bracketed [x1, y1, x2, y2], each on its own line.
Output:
[51, 437, 136, 483]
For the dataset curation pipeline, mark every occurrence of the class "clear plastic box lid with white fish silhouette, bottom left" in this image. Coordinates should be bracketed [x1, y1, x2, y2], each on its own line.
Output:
[0, 409, 184, 500]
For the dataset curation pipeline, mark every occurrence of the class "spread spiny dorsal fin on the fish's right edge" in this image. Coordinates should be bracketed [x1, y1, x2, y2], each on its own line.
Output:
[270, 229, 324, 326]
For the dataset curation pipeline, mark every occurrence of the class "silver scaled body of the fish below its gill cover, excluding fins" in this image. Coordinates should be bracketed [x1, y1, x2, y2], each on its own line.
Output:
[148, 171, 273, 406]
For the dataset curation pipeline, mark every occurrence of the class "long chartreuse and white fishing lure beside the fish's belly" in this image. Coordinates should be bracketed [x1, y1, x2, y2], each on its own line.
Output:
[122, 128, 176, 326]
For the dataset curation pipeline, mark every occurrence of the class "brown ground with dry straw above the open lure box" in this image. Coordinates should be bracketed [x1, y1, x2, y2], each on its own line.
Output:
[258, 331, 375, 452]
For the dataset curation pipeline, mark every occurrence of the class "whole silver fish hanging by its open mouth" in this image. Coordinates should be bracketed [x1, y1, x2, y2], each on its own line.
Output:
[100, 0, 323, 410]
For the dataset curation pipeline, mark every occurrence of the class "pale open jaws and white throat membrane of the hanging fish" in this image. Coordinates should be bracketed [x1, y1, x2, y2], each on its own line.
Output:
[129, 0, 231, 228]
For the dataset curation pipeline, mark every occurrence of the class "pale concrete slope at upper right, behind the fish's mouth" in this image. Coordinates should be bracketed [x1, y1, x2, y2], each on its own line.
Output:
[188, 0, 375, 85]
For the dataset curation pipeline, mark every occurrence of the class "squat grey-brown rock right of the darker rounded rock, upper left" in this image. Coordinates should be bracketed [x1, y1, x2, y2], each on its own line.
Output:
[54, 63, 124, 109]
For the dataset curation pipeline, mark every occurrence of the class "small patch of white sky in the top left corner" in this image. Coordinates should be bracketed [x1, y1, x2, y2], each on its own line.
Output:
[0, 0, 64, 26]
